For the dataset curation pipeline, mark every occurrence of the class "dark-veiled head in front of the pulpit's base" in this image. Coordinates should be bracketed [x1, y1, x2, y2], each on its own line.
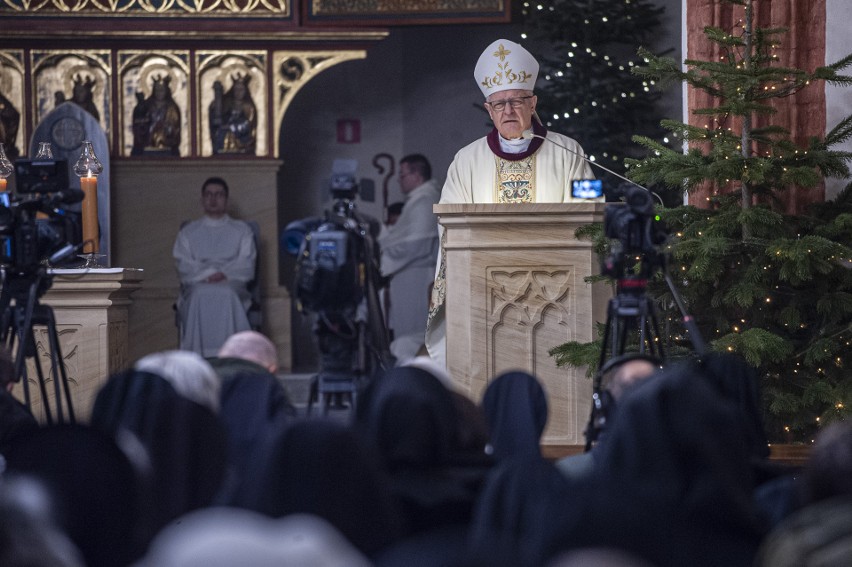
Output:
[482, 371, 548, 459]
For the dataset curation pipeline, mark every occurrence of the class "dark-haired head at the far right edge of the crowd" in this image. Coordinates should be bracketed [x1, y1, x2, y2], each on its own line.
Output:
[802, 421, 852, 504]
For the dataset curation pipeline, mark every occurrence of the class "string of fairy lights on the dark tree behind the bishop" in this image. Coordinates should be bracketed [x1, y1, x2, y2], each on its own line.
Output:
[521, 0, 677, 167]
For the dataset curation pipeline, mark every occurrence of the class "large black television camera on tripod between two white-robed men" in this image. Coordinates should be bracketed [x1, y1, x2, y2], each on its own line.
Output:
[282, 166, 393, 410]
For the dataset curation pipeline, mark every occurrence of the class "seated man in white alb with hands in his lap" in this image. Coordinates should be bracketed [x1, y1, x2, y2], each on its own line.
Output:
[172, 177, 257, 357]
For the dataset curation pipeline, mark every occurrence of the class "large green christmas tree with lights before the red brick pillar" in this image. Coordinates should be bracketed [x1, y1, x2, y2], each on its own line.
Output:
[553, 0, 852, 442]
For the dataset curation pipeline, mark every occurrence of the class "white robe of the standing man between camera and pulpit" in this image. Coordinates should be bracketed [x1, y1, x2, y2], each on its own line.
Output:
[379, 179, 441, 361]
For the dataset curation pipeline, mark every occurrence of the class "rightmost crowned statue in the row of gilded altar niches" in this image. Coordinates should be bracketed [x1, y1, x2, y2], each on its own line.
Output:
[209, 73, 257, 155]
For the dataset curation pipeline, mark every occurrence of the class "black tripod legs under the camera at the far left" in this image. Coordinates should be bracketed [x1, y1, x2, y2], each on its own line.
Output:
[0, 266, 75, 425]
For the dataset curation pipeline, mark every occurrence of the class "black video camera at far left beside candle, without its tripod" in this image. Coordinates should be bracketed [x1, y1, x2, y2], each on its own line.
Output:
[0, 160, 83, 276]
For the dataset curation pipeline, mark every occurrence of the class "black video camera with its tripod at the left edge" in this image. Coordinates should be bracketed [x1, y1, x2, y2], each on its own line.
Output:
[0, 160, 83, 423]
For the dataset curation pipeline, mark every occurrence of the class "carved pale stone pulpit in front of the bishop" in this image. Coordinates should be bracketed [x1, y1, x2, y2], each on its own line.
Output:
[434, 203, 611, 446]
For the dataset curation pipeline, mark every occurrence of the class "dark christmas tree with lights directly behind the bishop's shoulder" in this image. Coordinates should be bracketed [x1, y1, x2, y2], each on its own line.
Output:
[522, 0, 670, 201]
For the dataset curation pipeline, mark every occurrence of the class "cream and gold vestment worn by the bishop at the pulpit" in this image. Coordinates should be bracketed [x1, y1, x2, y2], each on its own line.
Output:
[426, 124, 603, 367]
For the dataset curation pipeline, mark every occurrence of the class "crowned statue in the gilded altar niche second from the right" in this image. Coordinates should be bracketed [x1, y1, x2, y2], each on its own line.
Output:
[130, 75, 181, 156]
